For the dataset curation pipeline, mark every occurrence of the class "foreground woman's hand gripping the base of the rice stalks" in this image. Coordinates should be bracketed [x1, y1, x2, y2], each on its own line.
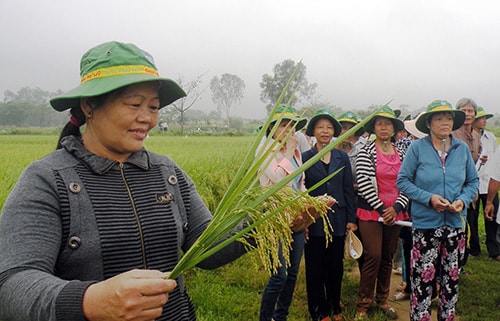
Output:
[83, 270, 177, 321]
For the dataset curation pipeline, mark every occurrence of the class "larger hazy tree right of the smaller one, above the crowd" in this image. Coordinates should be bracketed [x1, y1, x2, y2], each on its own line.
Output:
[260, 59, 318, 113]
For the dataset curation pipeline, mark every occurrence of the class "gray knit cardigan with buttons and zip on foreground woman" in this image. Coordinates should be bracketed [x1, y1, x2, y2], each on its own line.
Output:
[0, 137, 245, 321]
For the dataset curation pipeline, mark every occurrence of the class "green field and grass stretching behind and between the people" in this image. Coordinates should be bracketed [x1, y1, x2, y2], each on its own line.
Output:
[0, 135, 500, 321]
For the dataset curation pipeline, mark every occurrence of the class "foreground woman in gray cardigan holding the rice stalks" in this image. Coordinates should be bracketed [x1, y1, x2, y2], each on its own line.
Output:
[0, 42, 254, 321]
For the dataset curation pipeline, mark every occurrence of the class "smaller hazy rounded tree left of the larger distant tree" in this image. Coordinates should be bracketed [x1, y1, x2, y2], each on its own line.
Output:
[210, 73, 245, 125]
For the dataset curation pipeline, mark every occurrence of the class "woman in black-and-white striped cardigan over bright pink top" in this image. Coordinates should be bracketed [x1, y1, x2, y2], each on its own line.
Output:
[355, 106, 408, 320]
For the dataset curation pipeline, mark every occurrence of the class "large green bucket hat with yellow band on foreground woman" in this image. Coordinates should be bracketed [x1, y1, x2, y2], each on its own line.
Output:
[50, 41, 186, 111]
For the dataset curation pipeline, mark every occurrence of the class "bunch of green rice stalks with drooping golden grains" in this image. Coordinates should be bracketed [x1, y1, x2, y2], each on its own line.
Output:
[169, 67, 388, 279]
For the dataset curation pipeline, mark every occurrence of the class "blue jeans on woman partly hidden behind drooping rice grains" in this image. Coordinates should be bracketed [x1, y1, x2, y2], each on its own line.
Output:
[259, 232, 305, 321]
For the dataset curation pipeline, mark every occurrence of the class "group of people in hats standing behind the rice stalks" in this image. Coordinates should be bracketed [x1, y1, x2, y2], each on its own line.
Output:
[260, 98, 500, 320]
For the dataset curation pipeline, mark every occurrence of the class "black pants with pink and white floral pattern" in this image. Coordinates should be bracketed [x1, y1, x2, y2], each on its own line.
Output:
[410, 226, 465, 321]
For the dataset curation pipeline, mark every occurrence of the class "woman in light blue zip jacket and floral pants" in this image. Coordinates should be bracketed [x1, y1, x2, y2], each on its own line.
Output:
[397, 100, 479, 321]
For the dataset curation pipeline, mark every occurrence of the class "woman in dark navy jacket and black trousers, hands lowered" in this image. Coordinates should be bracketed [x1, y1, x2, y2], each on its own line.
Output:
[302, 109, 357, 320]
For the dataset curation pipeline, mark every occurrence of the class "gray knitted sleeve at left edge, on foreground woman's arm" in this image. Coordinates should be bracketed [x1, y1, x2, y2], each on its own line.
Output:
[0, 162, 91, 321]
